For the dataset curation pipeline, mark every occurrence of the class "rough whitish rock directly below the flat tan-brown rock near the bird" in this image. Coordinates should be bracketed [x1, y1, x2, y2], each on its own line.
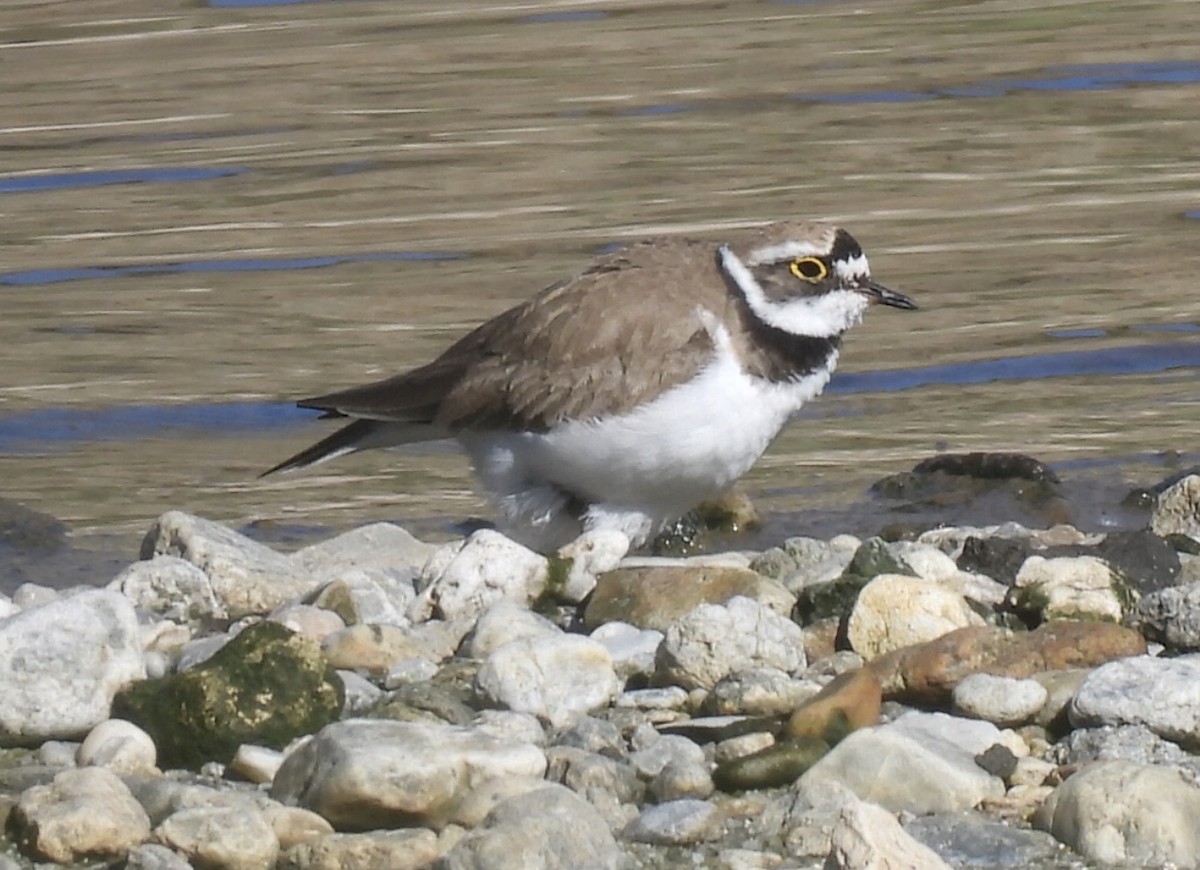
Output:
[656, 595, 805, 689]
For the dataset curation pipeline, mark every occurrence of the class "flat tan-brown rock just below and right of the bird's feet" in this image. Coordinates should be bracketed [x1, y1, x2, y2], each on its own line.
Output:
[583, 565, 796, 631]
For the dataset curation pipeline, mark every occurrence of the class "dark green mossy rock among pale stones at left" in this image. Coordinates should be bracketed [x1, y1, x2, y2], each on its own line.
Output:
[113, 622, 344, 769]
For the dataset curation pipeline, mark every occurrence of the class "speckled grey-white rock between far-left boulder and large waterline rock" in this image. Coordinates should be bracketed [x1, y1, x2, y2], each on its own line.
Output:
[107, 556, 229, 623]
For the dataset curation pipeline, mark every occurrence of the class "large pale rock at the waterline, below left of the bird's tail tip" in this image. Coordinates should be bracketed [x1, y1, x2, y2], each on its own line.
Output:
[142, 511, 316, 619]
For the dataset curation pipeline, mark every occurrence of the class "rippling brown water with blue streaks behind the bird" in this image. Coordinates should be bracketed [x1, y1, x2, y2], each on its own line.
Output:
[0, 0, 1200, 582]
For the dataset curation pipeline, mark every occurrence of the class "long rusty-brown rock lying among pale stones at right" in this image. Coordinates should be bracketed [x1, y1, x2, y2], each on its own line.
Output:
[869, 620, 1146, 706]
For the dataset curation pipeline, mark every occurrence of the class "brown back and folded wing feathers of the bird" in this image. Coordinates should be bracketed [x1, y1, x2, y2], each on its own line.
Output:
[301, 240, 732, 431]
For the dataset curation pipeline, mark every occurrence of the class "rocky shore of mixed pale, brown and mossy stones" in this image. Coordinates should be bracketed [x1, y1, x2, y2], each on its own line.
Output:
[0, 460, 1200, 870]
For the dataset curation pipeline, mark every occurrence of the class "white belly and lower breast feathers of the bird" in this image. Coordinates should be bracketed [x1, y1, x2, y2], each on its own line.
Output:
[462, 343, 836, 547]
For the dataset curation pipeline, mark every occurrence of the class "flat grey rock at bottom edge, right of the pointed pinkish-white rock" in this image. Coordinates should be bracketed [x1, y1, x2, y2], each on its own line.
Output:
[904, 812, 1062, 870]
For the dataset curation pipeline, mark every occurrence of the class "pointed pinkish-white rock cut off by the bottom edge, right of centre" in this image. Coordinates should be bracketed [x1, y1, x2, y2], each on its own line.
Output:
[826, 800, 950, 870]
